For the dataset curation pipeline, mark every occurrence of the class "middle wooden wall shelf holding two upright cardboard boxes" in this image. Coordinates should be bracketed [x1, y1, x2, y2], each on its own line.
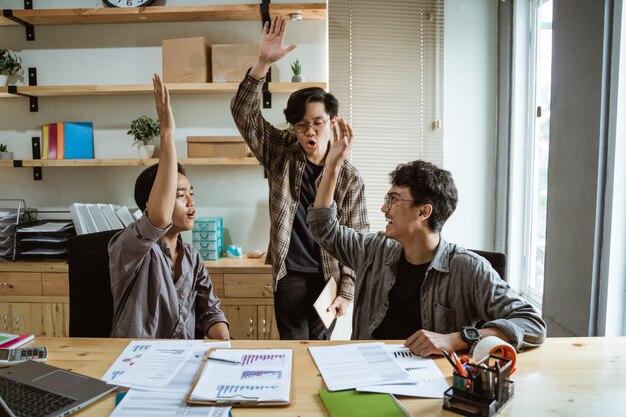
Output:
[0, 82, 327, 98]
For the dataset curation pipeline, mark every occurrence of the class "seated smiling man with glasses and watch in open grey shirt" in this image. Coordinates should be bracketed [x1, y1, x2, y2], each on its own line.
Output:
[307, 120, 546, 356]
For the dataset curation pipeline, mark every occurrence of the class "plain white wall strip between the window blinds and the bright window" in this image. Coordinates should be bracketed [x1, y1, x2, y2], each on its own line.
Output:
[443, 0, 497, 250]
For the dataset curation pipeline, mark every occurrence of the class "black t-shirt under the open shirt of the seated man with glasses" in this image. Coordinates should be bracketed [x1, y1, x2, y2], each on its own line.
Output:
[373, 252, 430, 340]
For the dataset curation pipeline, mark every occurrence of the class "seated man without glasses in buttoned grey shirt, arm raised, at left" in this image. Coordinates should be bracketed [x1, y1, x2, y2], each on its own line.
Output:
[109, 74, 229, 339]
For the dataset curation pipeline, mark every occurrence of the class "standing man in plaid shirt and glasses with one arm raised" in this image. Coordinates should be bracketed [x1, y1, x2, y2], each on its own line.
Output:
[231, 17, 369, 340]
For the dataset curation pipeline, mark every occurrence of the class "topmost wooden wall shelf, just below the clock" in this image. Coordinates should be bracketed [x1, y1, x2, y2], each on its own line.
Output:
[0, 3, 326, 26]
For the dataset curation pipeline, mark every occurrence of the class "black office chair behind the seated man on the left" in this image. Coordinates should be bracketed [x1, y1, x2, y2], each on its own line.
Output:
[69, 230, 119, 337]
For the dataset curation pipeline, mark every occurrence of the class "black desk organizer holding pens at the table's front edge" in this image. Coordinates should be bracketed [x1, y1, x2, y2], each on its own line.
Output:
[443, 355, 515, 417]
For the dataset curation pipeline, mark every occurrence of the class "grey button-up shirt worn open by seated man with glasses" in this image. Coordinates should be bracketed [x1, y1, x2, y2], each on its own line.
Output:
[307, 204, 546, 350]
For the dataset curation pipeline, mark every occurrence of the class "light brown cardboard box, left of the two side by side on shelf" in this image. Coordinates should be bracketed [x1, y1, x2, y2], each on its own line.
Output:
[161, 37, 211, 83]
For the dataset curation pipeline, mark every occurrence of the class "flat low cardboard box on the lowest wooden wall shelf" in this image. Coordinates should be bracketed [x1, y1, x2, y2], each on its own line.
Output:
[187, 136, 250, 158]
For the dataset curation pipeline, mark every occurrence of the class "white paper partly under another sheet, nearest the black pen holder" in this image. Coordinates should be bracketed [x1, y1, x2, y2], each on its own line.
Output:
[357, 345, 449, 398]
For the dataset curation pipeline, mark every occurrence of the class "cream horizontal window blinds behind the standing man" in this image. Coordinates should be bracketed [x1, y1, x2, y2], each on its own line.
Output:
[328, 0, 443, 231]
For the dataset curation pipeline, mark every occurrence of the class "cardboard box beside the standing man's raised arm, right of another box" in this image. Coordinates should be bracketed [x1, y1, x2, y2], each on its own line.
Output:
[211, 43, 259, 83]
